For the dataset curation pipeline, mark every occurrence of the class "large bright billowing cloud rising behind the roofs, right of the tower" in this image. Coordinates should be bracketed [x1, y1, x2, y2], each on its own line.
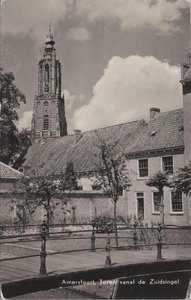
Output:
[73, 55, 182, 130]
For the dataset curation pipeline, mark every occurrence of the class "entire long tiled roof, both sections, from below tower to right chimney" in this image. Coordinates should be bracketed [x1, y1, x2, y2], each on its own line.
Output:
[23, 109, 184, 176]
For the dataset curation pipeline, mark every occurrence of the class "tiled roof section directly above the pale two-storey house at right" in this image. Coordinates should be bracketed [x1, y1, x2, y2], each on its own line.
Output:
[128, 109, 184, 154]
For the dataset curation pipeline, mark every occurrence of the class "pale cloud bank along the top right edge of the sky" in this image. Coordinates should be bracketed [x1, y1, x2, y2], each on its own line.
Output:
[77, 0, 188, 33]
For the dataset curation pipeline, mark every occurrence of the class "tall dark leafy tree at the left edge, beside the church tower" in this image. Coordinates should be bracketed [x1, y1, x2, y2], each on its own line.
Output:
[0, 70, 29, 164]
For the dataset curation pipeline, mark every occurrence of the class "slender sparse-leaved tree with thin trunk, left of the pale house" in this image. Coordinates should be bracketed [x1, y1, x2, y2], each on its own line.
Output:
[95, 134, 131, 246]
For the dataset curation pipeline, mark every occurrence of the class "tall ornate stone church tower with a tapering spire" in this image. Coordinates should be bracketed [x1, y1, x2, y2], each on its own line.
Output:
[32, 28, 67, 141]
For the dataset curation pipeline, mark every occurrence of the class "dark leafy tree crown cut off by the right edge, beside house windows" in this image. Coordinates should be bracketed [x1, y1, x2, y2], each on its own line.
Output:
[171, 162, 191, 195]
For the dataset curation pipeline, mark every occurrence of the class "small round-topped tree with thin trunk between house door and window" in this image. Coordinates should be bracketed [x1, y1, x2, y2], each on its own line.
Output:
[146, 171, 170, 225]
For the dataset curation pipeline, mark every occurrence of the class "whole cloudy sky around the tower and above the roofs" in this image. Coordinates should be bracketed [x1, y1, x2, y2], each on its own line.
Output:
[1, 0, 190, 133]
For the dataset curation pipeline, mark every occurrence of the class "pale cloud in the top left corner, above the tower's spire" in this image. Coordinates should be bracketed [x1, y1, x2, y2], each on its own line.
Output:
[2, 0, 74, 43]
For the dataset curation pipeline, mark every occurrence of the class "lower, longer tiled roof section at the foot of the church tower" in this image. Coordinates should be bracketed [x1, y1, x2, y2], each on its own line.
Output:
[23, 120, 147, 176]
